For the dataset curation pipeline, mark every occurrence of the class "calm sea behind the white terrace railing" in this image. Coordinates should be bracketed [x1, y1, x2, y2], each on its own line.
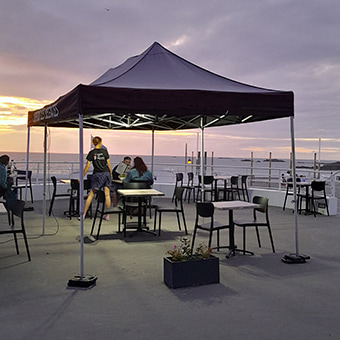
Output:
[1, 152, 332, 183]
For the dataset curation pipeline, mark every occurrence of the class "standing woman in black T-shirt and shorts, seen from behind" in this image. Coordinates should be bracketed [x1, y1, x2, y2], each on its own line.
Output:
[83, 136, 112, 219]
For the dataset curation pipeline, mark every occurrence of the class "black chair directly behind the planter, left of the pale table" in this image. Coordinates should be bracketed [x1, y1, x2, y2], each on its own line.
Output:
[191, 202, 230, 251]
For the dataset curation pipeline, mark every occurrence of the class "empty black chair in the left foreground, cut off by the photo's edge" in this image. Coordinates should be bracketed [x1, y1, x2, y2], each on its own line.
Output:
[0, 200, 31, 261]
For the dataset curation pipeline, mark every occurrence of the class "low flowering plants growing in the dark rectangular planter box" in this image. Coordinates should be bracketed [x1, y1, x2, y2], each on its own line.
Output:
[167, 237, 212, 262]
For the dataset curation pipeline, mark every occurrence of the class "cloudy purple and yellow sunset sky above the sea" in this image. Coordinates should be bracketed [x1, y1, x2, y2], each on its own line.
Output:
[0, 0, 340, 160]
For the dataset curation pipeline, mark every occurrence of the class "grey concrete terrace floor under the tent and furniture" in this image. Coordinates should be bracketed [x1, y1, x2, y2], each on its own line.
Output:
[0, 198, 340, 340]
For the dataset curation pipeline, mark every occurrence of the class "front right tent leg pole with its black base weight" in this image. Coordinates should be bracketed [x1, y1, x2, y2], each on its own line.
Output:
[281, 116, 310, 264]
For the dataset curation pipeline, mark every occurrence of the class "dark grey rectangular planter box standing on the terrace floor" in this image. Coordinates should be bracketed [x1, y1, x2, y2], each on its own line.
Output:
[163, 255, 220, 288]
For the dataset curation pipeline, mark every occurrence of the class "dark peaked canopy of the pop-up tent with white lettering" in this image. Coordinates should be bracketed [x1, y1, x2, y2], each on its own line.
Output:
[28, 42, 296, 286]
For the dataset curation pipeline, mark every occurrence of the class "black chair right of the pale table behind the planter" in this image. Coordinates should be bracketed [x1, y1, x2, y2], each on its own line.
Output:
[234, 196, 275, 255]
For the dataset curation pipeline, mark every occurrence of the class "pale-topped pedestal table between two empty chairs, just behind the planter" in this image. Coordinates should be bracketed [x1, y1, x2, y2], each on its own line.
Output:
[213, 201, 259, 258]
